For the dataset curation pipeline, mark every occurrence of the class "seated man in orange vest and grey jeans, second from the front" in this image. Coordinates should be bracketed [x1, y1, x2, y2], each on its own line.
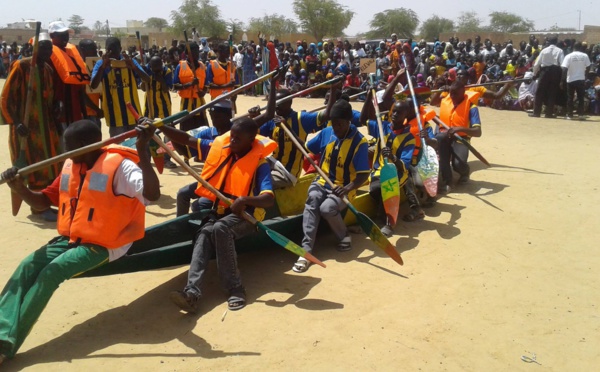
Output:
[169, 118, 277, 313]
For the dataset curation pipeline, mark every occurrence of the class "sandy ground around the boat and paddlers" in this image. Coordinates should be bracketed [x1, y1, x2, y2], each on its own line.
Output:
[0, 80, 600, 371]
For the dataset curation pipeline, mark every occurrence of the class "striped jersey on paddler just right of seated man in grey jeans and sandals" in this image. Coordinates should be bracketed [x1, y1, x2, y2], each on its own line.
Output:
[367, 120, 415, 179]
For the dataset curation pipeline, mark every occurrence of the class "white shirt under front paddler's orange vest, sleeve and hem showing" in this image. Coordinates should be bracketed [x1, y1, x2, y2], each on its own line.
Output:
[107, 159, 150, 262]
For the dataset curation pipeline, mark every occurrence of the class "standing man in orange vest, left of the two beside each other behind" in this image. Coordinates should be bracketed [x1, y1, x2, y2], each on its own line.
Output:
[173, 43, 207, 131]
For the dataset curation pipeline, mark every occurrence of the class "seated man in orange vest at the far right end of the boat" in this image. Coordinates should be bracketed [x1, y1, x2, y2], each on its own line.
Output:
[436, 81, 481, 194]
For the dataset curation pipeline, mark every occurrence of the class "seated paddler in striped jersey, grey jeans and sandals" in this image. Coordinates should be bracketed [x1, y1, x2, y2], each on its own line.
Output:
[292, 99, 370, 273]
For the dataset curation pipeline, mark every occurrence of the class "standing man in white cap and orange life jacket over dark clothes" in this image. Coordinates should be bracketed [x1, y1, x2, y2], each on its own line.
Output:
[48, 21, 90, 132]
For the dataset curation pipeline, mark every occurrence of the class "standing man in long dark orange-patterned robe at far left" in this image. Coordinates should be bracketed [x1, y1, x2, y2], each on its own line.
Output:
[1, 33, 60, 221]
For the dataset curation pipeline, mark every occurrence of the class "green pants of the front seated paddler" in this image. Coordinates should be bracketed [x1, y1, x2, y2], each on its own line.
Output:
[0, 237, 108, 358]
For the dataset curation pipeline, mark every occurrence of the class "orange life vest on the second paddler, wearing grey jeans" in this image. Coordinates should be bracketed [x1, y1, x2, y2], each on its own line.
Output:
[196, 132, 277, 206]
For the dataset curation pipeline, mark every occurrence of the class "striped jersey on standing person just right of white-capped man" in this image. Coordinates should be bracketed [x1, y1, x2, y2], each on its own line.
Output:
[92, 59, 142, 127]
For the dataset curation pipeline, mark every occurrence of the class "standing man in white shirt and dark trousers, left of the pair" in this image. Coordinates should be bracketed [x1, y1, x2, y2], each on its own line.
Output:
[529, 36, 564, 118]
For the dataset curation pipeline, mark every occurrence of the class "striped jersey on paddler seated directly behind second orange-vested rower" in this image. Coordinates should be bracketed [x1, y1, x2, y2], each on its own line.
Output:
[259, 110, 325, 177]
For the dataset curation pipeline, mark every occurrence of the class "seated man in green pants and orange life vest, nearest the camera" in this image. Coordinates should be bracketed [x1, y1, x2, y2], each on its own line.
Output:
[0, 120, 160, 363]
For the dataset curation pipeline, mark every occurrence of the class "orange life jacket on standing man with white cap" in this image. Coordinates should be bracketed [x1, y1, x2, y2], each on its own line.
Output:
[50, 44, 90, 85]
